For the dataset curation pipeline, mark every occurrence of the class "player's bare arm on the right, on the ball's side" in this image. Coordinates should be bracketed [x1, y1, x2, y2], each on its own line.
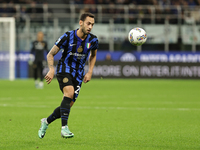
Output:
[83, 49, 97, 83]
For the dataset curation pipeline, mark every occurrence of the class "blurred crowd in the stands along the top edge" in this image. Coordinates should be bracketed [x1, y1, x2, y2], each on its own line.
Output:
[0, 0, 200, 24]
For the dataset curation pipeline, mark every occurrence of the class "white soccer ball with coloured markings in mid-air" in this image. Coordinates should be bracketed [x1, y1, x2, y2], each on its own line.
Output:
[128, 27, 147, 46]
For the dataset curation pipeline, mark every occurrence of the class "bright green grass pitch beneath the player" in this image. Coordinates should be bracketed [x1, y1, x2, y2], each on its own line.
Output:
[0, 79, 200, 150]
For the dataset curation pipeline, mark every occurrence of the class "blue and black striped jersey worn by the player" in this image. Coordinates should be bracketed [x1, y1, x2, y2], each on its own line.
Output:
[55, 29, 98, 82]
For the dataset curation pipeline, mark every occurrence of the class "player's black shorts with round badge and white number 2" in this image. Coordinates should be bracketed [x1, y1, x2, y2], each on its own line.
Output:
[56, 73, 82, 102]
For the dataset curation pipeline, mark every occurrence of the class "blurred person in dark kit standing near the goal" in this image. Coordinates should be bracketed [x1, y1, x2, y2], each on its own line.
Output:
[29, 31, 48, 89]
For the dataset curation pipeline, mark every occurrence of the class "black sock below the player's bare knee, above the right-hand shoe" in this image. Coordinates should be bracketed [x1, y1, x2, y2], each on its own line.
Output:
[60, 97, 72, 126]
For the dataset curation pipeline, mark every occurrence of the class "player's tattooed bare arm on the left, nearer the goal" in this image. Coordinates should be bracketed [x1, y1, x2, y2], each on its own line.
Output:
[44, 45, 60, 84]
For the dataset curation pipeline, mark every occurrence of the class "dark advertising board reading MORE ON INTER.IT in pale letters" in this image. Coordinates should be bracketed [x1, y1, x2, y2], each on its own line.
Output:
[85, 62, 200, 79]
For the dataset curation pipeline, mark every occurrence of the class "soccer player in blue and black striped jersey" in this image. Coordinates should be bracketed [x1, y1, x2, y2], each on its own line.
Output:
[38, 13, 98, 138]
